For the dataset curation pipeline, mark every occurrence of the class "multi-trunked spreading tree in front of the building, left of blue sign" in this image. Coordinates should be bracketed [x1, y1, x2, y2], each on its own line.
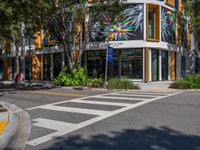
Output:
[39, 0, 121, 73]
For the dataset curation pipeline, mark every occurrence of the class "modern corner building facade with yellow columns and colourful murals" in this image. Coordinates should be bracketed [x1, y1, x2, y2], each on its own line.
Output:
[0, 0, 195, 82]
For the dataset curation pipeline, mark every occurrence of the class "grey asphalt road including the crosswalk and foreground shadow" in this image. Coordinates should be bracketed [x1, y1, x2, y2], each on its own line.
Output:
[0, 89, 200, 150]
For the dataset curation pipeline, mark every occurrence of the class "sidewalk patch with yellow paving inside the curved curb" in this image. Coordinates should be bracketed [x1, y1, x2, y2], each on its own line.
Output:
[0, 104, 9, 137]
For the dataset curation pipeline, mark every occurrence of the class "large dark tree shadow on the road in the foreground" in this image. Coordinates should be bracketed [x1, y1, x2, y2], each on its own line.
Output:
[46, 127, 200, 150]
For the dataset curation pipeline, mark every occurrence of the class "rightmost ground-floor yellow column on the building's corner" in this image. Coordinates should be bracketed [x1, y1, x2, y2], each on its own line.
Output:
[170, 52, 176, 81]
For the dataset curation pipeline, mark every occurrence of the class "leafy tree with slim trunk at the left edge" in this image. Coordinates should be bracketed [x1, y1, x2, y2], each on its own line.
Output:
[0, 0, 45, 79]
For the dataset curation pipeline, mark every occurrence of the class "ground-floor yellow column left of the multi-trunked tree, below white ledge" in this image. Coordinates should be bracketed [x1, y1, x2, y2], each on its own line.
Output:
[32, 55, 41, 80]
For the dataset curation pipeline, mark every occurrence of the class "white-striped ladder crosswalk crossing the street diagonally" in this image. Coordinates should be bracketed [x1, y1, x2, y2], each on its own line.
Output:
[27, 91, 180, 146]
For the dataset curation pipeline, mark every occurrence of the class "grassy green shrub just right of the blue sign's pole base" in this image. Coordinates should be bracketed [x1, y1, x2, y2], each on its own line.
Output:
[108, 78, 140, 90]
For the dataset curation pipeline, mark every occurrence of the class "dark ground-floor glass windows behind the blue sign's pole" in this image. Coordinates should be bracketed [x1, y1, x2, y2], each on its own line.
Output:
[87, 49, 143, 79]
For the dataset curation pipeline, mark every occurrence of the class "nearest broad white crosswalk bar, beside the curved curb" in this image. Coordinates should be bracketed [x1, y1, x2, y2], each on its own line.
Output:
[32, 118, 75, 131]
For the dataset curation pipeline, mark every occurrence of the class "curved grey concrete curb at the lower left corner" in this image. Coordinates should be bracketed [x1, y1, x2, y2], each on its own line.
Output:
[0, 102, 31, 150]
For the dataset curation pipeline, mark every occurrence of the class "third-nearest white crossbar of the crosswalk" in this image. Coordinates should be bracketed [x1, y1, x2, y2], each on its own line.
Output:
[73, 100, 129, 106]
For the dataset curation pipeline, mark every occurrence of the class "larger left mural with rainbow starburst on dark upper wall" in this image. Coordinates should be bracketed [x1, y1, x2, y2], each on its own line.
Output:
[90, 4, 144, 42]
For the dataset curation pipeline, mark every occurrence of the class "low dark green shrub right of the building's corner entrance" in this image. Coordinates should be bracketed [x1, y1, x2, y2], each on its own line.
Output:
[170, 79, 192, 89]
